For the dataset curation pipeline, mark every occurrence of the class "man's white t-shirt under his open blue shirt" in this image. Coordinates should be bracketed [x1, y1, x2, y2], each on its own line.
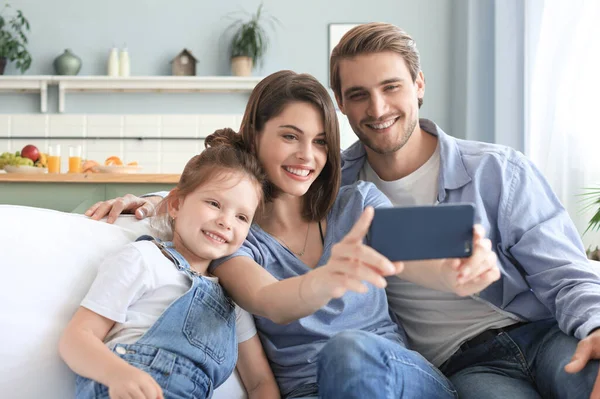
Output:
[359, 142, 516, 366]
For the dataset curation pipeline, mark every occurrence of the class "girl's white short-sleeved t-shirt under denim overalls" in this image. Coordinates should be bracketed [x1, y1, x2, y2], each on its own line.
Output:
[81, 241, 256, 346]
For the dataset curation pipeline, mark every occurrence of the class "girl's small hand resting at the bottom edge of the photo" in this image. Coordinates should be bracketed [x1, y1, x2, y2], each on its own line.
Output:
[107, 365, 164, 399]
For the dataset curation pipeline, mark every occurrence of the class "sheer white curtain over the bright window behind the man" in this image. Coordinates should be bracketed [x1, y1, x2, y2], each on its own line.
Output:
[525, 0, 600, 247]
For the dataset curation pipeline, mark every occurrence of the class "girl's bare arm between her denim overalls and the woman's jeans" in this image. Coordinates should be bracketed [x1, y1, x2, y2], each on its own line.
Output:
[236, 335, 280, 399]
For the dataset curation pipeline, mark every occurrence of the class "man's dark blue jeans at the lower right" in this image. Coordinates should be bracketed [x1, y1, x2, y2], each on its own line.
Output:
[440, 320, 598, 399]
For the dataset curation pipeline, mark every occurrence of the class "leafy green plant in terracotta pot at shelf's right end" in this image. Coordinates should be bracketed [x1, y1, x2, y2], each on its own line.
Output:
[227, 3, 279, 76]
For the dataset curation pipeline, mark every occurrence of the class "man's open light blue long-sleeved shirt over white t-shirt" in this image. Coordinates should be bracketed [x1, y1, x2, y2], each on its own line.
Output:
[342, 119, 600, 339]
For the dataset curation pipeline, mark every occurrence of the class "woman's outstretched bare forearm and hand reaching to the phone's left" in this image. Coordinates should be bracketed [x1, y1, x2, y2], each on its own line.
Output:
[212, 207, 402, 324]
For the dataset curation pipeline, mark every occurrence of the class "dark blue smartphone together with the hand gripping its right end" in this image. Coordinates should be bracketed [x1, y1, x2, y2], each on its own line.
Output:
[370, 204, 500, 296]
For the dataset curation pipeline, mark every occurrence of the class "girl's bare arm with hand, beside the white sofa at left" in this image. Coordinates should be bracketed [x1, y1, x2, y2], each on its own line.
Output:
[59, 307, 163, 399]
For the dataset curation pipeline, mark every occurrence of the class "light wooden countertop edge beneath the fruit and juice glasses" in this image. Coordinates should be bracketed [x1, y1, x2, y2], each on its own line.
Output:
[0, 173, 179, 184]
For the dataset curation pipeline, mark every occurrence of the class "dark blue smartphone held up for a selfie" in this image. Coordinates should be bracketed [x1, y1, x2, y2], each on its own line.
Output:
[369, 204, 475, 261]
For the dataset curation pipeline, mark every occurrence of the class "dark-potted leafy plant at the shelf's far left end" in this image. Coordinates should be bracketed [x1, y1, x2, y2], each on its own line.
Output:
[0, 4, 31, 75]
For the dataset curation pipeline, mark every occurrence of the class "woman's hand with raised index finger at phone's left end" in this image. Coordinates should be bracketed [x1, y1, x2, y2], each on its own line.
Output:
[300, 207, 403, 300]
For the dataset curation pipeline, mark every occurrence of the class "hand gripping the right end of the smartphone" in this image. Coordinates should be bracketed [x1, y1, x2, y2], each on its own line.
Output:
[441, 225, 500, 296]
